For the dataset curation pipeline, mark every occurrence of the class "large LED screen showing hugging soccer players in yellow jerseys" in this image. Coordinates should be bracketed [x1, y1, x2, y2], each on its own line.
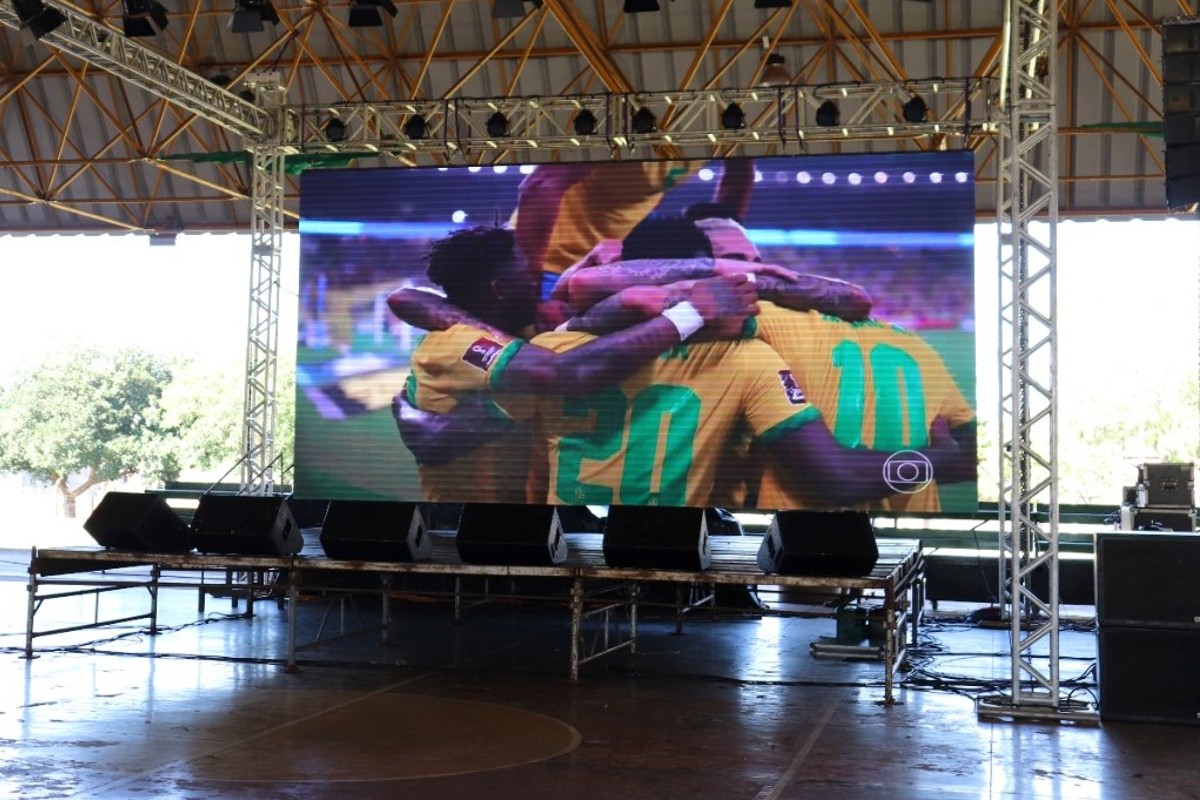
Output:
[295, 151, 977, 511]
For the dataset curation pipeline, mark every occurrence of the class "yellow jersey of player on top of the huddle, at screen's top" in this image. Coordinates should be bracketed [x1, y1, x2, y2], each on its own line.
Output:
[514, 161, 703, 275]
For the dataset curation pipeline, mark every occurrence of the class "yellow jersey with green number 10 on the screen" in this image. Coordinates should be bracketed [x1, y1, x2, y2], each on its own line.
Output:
[756, 302, 974, 511]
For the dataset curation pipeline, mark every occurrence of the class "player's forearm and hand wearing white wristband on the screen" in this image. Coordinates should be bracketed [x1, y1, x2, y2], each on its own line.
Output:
[492, 275, 758, 396]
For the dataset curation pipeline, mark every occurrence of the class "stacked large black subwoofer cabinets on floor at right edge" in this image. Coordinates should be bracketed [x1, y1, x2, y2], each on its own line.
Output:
[1096, 533, 1200, 726]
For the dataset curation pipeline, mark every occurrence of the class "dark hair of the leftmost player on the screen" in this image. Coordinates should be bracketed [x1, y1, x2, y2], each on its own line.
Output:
[425, 225, 516, 311]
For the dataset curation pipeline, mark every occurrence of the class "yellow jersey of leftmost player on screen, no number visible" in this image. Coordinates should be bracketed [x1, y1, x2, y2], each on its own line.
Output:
[406, 324, 533, 503]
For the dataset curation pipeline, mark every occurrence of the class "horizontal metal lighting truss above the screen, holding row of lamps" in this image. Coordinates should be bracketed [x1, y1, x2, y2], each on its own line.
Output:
[281, 78, 995, 154]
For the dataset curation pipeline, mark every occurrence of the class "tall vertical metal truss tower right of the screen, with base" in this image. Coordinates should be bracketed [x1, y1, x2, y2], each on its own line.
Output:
[976, 0, 1098, 721]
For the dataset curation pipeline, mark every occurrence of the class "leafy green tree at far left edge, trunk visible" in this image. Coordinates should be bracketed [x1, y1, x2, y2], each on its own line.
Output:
[0, 348, 180, 517]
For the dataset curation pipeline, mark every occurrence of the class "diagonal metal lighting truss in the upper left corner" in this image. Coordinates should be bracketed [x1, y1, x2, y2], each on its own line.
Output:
[0, 0, 276, 139]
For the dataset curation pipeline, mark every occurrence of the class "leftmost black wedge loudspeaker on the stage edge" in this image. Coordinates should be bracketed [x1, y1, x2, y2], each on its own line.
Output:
[83, 492, 192, 553]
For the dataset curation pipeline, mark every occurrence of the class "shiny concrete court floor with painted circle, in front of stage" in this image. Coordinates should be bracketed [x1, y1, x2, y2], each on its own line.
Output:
[0, 551, 1200, 800]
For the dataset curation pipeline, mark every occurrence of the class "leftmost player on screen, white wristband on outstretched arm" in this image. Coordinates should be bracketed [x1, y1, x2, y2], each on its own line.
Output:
[398, 228, 757, 503]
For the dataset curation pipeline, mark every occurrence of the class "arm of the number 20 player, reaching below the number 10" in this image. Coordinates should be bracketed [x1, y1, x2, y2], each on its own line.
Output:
[768, 417, 977, 506]
